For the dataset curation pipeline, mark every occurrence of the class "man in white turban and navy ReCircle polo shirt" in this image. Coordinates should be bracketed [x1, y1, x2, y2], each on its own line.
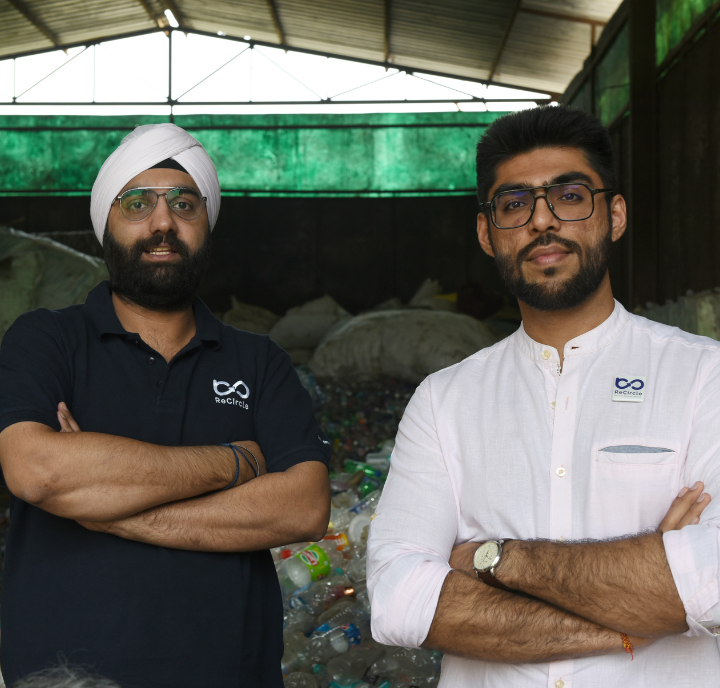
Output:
[0, 124, 330, 688]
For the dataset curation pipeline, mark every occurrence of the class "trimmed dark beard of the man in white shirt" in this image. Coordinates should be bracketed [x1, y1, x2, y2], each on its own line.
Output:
[491, 223, 613, 311]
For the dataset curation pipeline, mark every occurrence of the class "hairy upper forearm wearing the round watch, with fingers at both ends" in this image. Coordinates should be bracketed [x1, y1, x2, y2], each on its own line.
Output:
[450, 483, 710, 638]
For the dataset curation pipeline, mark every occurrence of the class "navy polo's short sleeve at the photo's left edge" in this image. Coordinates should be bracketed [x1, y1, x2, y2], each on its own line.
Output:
[0, 309, 72, 432]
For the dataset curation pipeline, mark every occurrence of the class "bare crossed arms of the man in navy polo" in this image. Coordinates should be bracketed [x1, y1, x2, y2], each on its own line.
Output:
[0, 404, 330, 552]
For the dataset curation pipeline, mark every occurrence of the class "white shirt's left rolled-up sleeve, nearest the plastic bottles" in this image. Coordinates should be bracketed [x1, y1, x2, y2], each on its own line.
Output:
[367, 379, 458, 647]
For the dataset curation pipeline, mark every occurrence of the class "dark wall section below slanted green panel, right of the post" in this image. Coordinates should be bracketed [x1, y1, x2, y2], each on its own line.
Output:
[656, 12, 720, 303]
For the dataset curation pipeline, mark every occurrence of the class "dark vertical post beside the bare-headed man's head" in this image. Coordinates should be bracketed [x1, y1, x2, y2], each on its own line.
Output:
[627, 0, 658, 307]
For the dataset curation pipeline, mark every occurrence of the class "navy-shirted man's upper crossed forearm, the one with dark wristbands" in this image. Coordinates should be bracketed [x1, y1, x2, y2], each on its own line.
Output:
[0, 408, 254, 521]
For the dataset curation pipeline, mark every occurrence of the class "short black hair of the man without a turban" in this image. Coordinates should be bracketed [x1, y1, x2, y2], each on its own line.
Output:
[476, 105, 617, 203]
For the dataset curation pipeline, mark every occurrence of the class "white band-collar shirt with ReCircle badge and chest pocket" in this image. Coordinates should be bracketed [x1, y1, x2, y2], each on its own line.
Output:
[368, 302, 720, 688]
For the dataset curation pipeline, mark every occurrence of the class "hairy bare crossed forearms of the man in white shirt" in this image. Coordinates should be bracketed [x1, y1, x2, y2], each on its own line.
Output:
[424, 483, 710, 662]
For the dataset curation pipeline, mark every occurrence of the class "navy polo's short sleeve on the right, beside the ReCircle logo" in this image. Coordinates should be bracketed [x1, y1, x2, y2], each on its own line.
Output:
[255, 339, 330, 473]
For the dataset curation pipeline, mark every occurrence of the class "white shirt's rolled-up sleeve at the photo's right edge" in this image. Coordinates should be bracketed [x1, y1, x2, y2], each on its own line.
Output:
[663, 357, 720, 636]
